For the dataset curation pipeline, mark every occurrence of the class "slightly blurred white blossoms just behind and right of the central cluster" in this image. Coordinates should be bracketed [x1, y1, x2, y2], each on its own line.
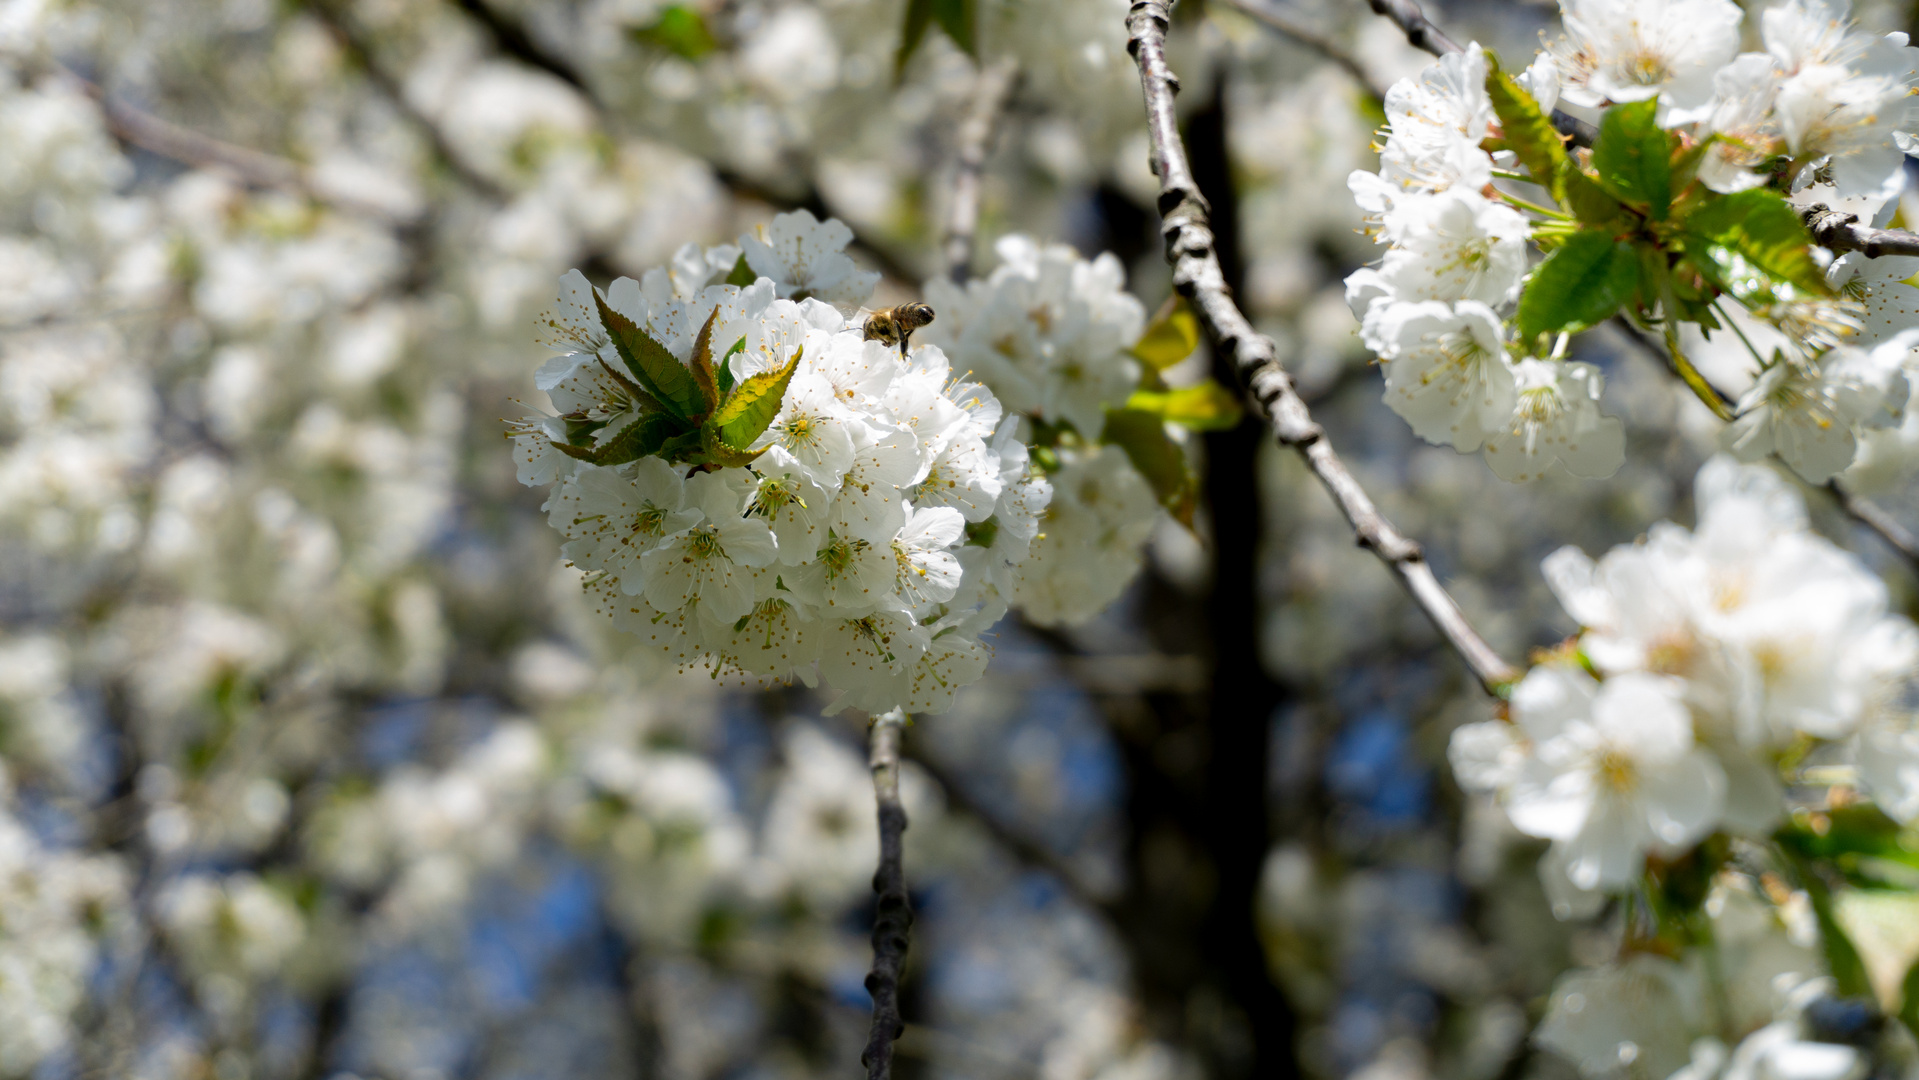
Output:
[921, 234, 1159, 625]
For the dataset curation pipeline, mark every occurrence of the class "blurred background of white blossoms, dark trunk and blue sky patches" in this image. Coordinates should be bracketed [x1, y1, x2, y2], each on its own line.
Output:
[0, 0, 1919, 1080]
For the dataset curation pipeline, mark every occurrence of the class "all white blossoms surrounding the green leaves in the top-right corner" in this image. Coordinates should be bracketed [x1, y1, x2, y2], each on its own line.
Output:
[1347, 0, 1919, 481]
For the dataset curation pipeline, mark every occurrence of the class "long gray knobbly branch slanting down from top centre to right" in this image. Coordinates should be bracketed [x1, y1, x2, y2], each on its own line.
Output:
[1126, 0, 1518, 694]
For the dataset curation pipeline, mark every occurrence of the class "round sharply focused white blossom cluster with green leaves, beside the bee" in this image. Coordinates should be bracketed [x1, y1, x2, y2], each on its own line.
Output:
[516, 211, 1052, 712]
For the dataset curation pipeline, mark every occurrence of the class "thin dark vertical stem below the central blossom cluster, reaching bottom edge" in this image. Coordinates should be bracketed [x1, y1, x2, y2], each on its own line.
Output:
[860, 710, 913, 1080]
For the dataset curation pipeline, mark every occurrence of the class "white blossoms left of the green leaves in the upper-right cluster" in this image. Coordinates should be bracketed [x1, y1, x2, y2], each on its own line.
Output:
[1345, 42, 1625, 481]
